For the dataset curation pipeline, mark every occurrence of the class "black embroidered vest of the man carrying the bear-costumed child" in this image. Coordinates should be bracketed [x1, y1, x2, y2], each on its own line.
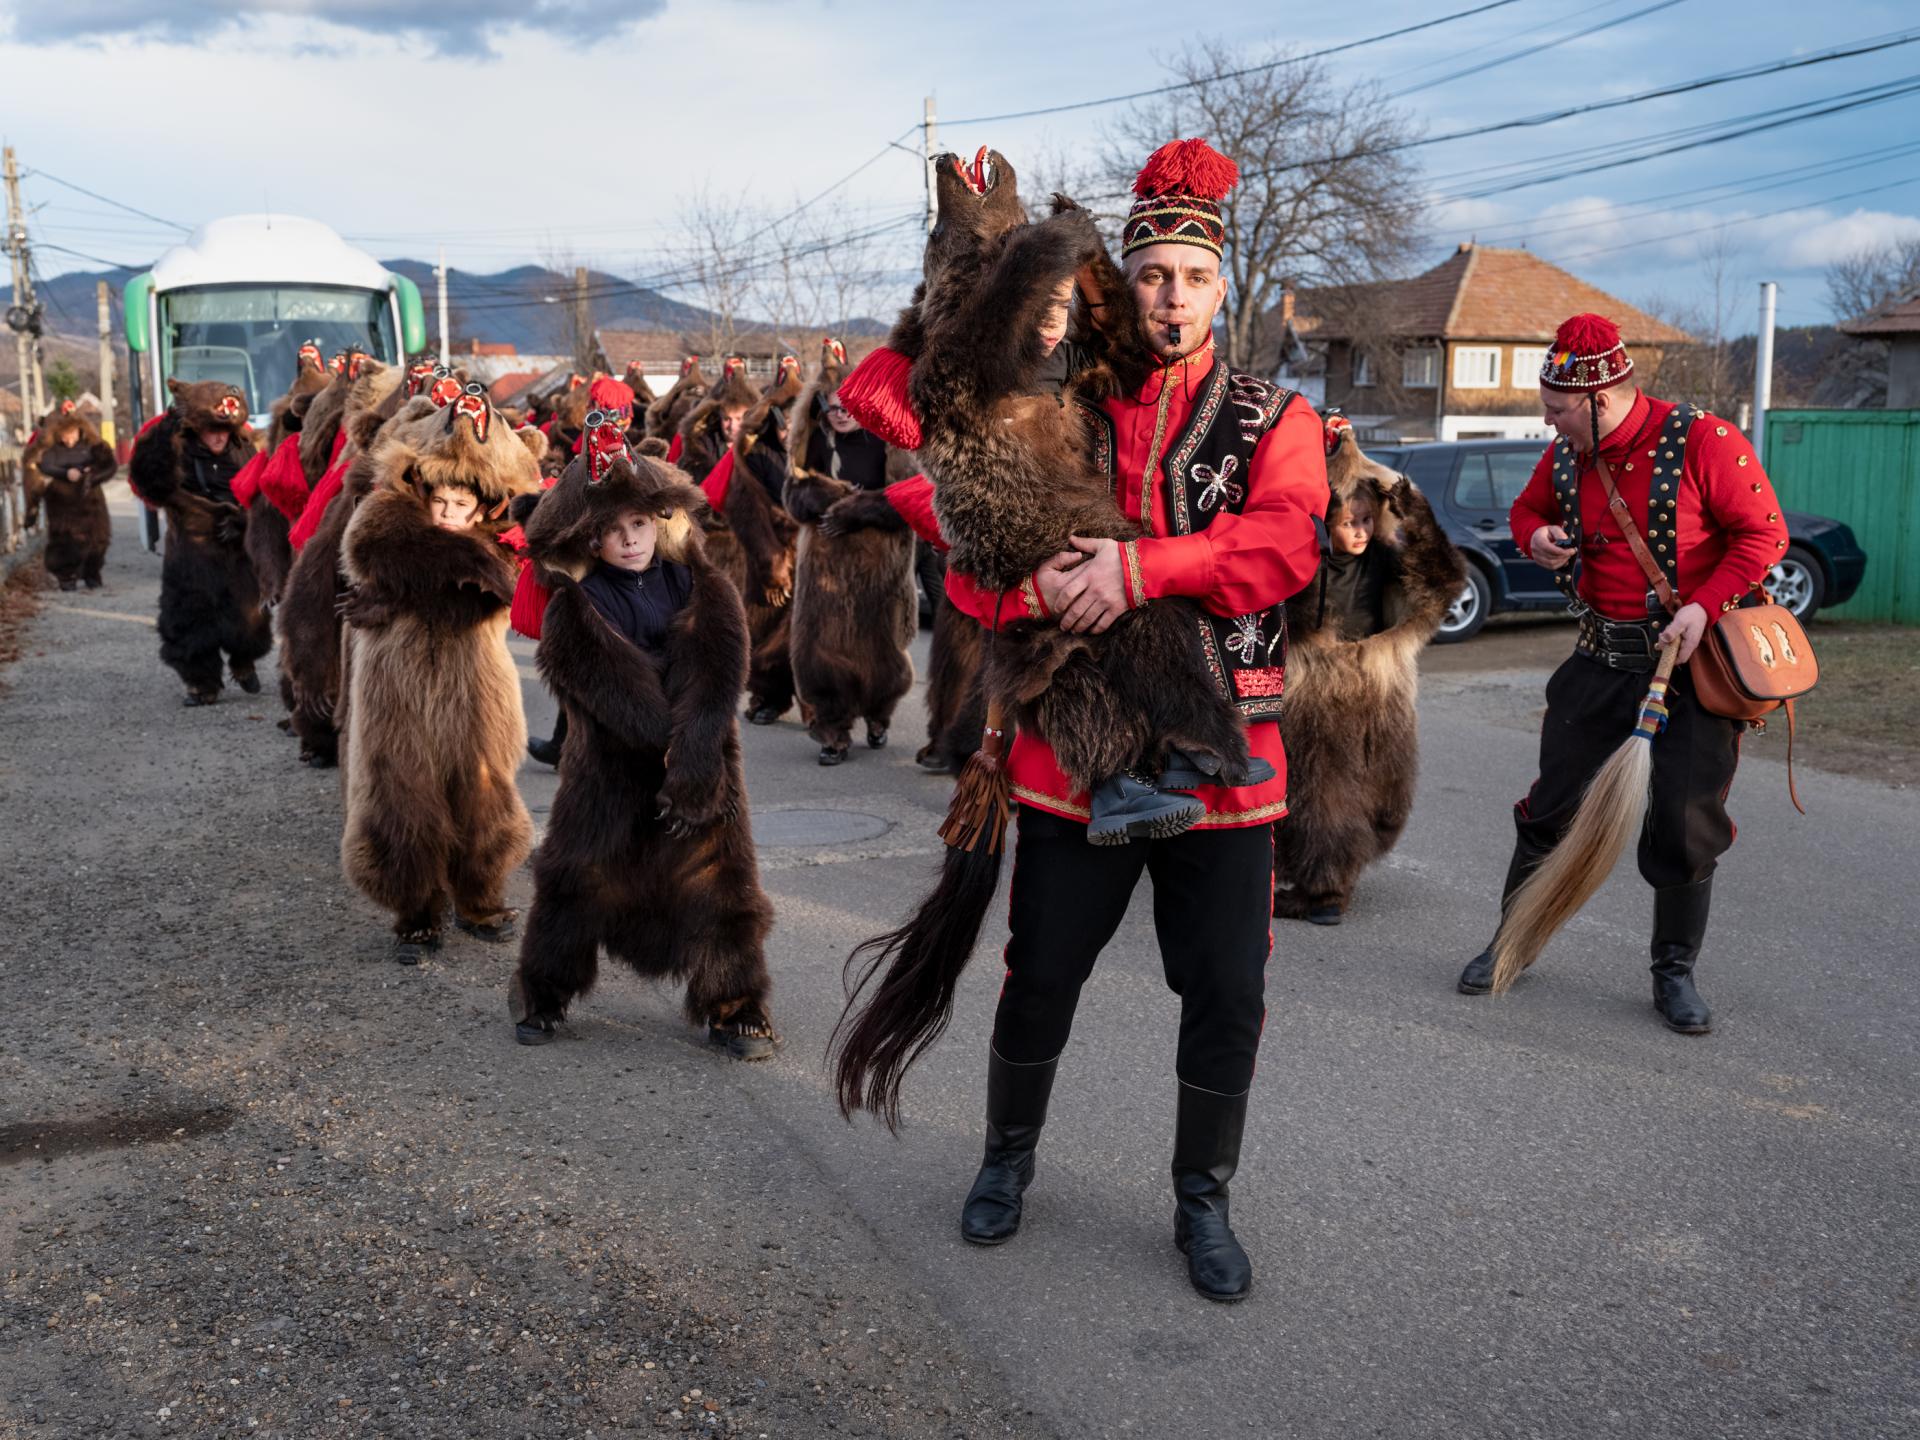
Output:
[1081, 363, 1294, 720]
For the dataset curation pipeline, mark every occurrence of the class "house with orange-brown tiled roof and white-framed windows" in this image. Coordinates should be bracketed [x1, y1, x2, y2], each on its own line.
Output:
[1271, 242, 1692, 440]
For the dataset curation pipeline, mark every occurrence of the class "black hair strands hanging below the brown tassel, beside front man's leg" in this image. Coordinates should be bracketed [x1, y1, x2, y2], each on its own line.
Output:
[828, 845, 1000, 1131]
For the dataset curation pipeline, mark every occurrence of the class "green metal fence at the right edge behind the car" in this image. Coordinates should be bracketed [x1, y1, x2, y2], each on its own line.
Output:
[1763, 411, 1920, 624]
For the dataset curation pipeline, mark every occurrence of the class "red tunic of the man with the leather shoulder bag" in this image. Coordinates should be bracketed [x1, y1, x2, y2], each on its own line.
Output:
[1509, 392, 1788, 620]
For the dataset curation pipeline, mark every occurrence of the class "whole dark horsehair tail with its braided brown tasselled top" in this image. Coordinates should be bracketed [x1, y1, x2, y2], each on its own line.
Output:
[828, 706, 1012, 1131]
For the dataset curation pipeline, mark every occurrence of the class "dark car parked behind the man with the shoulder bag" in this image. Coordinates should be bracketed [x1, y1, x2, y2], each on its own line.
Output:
[1367, 440, 1866, 643]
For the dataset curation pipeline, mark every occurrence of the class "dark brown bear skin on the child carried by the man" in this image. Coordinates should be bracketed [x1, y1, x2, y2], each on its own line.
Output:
[889, 154, 1248, 789]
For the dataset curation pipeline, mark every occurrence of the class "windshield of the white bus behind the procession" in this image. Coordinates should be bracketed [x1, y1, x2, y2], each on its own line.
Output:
[159, 284, 399, 417]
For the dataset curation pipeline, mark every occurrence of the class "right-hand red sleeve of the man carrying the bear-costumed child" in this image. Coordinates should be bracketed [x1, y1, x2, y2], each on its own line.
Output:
[1123, 401, 1329, 614]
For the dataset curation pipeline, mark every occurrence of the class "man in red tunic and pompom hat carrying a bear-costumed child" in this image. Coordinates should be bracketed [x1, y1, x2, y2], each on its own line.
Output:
[947, 140, 1327, 1300]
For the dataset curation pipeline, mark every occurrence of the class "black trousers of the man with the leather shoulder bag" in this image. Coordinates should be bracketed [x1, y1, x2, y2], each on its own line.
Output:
[1513, 651, 1745, 889]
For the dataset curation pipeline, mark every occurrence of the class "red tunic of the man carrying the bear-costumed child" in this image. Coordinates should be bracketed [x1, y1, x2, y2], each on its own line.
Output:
[936, 346, 1327, 828]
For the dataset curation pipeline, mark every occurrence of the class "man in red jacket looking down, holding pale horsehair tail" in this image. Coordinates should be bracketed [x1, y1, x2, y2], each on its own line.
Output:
[1459, 315, 1788, 1035]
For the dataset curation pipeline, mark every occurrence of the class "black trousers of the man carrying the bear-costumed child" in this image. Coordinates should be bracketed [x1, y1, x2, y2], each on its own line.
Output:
[993, 804, 1273, 1094]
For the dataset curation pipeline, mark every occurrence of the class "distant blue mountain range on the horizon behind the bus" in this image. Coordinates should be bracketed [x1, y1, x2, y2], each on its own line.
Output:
[38, 259, 887, 355]
